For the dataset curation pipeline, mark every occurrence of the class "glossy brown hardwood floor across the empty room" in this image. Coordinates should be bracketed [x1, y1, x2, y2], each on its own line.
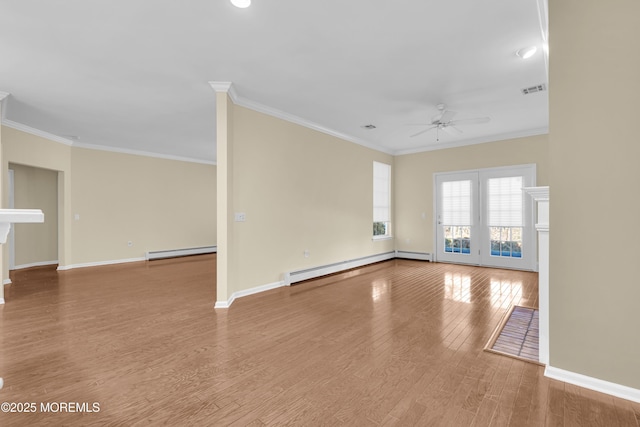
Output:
[0, 255, 640, 426]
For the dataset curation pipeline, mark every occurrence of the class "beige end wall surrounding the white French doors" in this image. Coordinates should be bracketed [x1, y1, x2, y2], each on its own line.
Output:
[394, 135, 548, 253]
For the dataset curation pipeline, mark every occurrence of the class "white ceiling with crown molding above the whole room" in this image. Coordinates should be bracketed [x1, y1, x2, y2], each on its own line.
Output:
[0, 0, 548, 162]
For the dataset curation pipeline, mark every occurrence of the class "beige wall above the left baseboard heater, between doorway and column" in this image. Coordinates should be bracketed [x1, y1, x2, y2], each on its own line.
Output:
[71, 148, 216, 264]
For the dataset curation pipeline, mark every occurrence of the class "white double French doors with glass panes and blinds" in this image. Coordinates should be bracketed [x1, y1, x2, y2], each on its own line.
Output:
[434, 165, 537, 270]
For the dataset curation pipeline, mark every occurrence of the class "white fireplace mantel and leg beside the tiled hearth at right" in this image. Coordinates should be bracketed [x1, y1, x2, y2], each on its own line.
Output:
[523, 187, 549, 365]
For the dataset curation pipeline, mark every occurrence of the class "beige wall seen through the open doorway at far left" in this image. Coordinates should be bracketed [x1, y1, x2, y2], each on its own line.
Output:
[9, 164, 58, 268]
